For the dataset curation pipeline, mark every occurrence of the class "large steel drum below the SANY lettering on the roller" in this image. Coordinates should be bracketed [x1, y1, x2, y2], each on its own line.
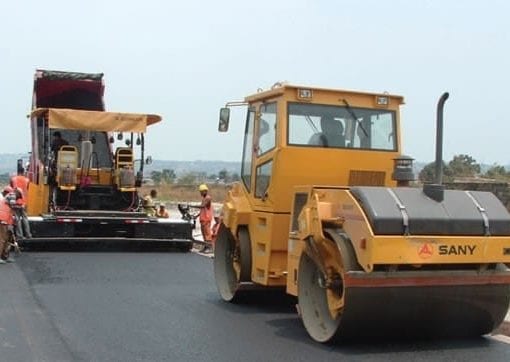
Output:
[298, 247, 510, 342]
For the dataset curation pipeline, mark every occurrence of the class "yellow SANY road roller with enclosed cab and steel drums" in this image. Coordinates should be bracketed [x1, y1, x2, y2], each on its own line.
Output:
[214, 83, 510, 342]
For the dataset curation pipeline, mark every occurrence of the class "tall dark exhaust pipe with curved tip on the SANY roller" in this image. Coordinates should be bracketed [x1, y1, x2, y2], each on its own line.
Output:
[423, 92, 450, 202]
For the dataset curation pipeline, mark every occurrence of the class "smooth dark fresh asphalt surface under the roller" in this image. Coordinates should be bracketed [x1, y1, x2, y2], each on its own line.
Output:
[0, 252, 510, 361]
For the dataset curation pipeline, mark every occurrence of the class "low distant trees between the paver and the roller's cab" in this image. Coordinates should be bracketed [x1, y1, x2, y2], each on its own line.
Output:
[150, 169, 240, 185]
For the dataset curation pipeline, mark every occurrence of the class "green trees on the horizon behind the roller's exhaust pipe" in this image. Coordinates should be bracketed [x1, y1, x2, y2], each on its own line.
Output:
[418, 154, 510, 182]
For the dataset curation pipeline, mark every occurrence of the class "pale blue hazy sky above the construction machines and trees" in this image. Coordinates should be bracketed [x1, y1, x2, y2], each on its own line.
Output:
[0, 0, 510, 165]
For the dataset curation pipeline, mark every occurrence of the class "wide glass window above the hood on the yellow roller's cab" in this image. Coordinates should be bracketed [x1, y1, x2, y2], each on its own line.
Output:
[287, 103, 397, 151]
